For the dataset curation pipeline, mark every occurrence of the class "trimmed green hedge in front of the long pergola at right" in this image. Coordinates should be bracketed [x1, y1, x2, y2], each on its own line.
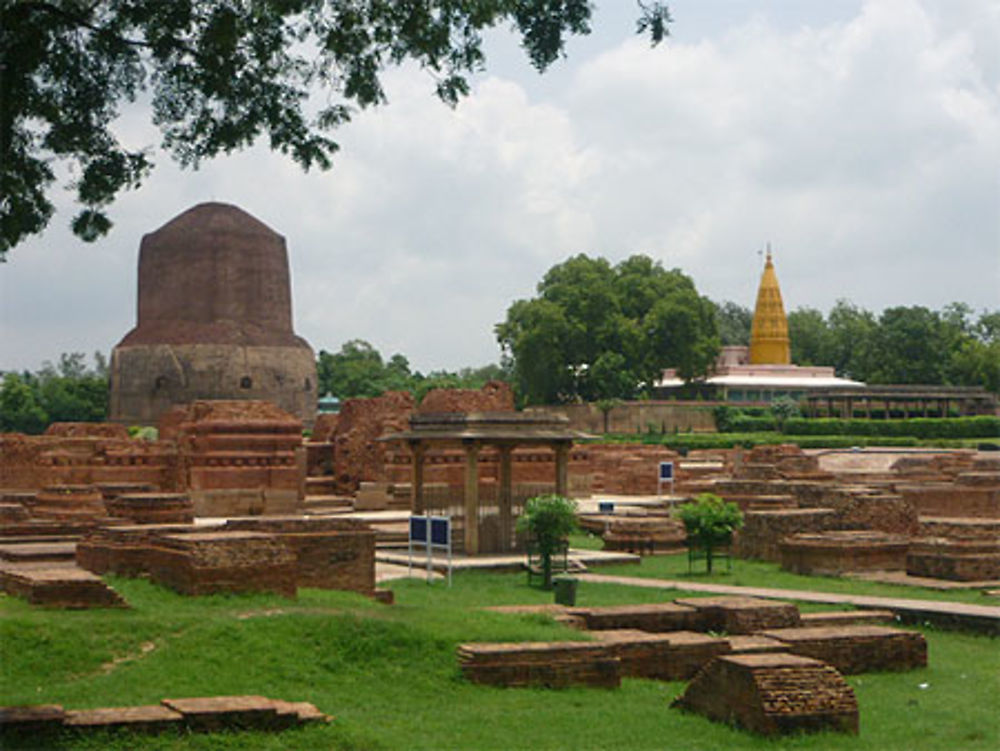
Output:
[784, 415, 1000, 438]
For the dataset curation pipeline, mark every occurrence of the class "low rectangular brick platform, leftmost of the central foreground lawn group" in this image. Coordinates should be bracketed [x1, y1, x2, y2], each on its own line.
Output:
[458, 642, 621, 688]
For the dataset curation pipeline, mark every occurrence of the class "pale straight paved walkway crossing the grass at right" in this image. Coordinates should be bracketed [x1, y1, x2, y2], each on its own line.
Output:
[577, 574, 1000, 635]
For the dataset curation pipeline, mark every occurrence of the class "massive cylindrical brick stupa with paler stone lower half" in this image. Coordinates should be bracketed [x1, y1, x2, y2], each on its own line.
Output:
[110, 203, 316, 425]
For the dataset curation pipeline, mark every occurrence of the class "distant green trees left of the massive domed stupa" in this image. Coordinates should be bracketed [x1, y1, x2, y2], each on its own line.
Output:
[0, 352, 108, 434]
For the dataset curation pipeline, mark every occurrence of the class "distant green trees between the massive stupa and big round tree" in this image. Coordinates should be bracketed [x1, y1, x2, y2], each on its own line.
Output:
[316, 339, 509, 402]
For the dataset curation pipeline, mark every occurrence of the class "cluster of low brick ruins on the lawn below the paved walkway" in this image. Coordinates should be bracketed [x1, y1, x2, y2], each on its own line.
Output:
[457, 597, 927, 735]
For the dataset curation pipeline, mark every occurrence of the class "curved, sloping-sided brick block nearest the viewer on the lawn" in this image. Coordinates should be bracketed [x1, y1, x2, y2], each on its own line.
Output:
[673, 654, 858, 736]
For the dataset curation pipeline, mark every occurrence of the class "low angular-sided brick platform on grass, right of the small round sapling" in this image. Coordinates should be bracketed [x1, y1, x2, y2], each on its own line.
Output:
[778, 530, 910, 576]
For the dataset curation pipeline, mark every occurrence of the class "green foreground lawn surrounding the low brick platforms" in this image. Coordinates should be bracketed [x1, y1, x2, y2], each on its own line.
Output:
[0, 559, 1000, 751]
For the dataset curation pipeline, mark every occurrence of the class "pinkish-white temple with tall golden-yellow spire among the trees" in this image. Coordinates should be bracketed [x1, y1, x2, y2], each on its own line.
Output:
[657, 248, 864, 402]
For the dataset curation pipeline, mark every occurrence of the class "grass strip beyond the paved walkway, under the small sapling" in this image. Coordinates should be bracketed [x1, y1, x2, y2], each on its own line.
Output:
[594, 553, 996, 605]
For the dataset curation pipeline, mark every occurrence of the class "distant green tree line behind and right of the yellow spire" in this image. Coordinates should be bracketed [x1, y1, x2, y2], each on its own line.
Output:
[716, 300, 1000, 393]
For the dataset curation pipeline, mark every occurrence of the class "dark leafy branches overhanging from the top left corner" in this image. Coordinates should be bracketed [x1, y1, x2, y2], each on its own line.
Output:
[0, 0, 670, 260]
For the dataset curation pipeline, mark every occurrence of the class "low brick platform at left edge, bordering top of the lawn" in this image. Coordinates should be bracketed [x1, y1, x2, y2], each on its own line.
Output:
[0, 563, 128, 609]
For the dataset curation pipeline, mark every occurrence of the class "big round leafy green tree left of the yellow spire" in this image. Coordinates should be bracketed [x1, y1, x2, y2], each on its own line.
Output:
[496, 254, 719, 404]
